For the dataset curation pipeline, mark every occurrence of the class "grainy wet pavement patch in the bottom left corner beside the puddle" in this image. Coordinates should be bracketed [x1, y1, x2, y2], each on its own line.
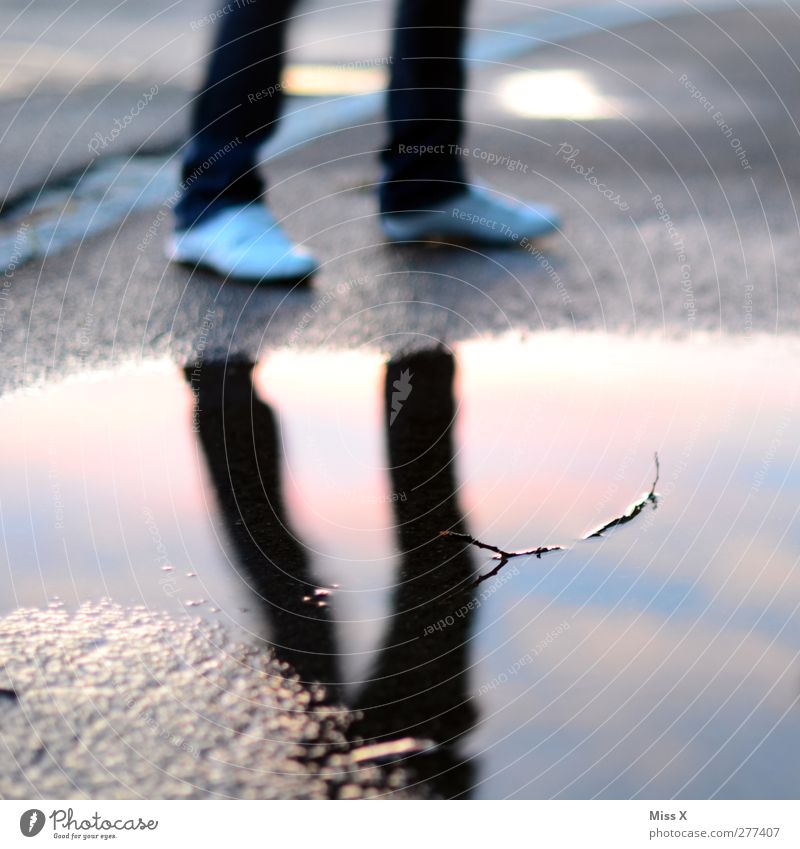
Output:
[0, 604, 424, 799]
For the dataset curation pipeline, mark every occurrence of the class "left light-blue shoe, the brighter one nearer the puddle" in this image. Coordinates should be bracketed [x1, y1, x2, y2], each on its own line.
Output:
[166, 203, 318, 283]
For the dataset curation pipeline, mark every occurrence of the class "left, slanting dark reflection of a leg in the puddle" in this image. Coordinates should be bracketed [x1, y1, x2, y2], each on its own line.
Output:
[186, 361, 339, 684]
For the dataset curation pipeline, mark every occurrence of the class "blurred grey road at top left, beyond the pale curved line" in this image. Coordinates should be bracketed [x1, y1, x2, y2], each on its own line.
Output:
[0, 0, 563, 207]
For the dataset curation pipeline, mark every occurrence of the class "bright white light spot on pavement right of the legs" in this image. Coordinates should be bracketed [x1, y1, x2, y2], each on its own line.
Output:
[499, 71, 616, 121]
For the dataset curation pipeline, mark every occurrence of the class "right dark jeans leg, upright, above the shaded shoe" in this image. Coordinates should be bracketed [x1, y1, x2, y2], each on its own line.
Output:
[380, 0, 467, 212]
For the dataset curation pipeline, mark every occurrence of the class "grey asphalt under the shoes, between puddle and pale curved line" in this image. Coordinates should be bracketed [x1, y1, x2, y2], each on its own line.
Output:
[1, 0, 800, 388]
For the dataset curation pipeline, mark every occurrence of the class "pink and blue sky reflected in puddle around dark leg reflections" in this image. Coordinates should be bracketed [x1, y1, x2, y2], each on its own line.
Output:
[0, 334, 800, 796]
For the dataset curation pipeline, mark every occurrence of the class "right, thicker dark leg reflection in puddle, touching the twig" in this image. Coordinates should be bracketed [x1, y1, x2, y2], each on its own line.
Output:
[352, 350, 475, 797]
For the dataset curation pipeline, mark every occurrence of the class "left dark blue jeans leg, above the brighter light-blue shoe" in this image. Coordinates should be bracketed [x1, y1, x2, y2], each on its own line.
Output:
[175, 0, 294, 229]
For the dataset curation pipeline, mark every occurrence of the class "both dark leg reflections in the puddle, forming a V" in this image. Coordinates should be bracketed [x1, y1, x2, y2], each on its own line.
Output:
[185, 349, 477, 797]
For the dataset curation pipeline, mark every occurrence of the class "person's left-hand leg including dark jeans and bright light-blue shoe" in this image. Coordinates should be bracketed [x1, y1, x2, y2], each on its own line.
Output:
[166, 0, 317, 283]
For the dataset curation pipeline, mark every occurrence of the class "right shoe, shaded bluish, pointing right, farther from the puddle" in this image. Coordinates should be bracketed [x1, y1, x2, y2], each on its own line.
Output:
[381, 186, 561, 246]
